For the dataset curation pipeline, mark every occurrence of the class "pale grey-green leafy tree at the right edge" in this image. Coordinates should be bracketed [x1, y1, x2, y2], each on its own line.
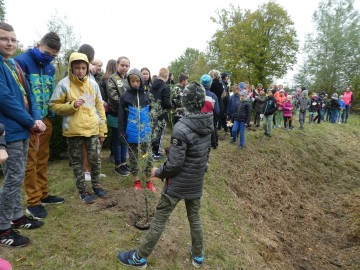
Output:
[295, 0, 360, 93]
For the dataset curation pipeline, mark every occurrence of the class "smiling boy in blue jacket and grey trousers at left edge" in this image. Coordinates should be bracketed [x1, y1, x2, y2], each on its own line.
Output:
[0, 22, 46, 247]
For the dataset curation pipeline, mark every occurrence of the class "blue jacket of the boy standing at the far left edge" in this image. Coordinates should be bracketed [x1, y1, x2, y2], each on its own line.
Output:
[0, 55, 41, 142]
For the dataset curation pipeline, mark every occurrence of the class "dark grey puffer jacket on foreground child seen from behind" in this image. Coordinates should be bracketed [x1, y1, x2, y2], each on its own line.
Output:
[155, 113, 214, 200]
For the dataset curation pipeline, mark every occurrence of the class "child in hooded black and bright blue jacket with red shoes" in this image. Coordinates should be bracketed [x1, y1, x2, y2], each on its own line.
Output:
[118, 68, 156, 192]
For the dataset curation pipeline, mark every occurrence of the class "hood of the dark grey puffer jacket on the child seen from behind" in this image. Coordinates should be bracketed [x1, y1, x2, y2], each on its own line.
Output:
[179, 113, 214, 136]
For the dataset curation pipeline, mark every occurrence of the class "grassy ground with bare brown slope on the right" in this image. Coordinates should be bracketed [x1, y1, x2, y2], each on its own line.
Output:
[0, 115, 360, 270]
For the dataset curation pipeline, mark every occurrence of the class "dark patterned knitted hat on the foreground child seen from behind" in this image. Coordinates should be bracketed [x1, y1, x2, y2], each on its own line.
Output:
[181, 80, 204, 113]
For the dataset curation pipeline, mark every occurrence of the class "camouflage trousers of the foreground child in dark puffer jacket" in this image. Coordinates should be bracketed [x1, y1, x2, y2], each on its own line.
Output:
[137, 193, 203, 258]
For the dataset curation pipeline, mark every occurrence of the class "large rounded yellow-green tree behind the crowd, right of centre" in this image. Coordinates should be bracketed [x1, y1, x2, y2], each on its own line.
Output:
[209, 2, 299, 86]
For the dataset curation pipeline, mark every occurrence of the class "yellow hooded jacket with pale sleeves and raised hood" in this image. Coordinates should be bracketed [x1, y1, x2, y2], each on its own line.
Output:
[49, 53, 107, 137]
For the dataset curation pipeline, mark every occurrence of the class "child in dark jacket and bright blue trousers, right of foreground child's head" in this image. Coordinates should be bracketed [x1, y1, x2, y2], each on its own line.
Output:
[232, 92, 251, 148]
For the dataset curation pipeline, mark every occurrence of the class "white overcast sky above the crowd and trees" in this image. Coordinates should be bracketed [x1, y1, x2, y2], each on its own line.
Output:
[4, 0, 360, 84]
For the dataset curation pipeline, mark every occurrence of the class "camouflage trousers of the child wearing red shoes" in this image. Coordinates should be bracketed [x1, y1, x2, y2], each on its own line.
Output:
[128, 143, 153, 180]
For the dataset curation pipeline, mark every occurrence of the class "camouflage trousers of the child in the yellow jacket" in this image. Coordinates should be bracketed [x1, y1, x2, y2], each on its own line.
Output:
[67, 136, 101, 193]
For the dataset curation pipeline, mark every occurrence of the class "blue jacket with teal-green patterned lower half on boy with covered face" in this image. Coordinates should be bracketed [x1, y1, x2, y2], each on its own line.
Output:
[14, 49, 55, 118]
